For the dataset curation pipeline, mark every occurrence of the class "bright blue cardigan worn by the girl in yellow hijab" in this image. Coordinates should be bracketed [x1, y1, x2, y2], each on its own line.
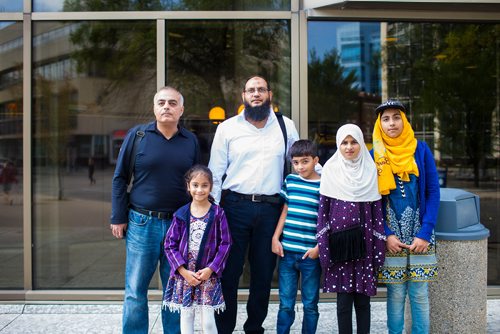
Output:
[370, 140, 440, 242]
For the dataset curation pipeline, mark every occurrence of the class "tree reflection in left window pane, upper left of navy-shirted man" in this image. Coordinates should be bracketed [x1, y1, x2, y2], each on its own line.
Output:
[70, 21, 156, 118]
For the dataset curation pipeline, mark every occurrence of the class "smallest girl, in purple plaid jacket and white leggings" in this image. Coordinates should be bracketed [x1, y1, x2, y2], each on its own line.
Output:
[163, 165, 231, 334]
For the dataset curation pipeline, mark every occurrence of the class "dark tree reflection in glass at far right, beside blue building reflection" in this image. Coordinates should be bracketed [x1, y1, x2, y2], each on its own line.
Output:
[385, 23, 500, 284]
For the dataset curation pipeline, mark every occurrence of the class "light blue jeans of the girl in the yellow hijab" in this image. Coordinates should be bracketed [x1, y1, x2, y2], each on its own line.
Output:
[386, 282, 430, 334]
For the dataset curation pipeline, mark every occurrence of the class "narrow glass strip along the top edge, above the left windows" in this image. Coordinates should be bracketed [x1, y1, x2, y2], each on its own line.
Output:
[34, 0, 290, 12]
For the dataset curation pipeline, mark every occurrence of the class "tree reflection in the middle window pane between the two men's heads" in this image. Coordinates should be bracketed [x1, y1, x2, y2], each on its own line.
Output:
[166, 20, 291, 163]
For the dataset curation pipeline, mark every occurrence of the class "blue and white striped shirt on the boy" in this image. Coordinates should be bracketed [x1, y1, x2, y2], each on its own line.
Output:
[280, 174, 320, 253]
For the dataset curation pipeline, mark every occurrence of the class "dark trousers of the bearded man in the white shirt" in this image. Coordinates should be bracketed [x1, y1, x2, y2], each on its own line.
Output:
[215, 193, 281, 334]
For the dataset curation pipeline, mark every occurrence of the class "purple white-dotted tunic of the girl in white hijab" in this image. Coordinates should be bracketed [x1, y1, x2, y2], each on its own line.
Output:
[317, 195, 385, 296]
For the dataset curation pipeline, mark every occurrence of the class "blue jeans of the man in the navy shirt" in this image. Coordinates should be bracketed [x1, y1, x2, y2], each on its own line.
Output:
[123, 210, 180, 334]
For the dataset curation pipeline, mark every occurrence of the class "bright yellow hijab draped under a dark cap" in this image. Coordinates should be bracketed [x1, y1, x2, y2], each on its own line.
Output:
[373, 110, 418, 195]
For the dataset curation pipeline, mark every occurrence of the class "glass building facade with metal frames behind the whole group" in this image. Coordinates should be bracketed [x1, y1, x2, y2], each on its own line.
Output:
[0, 0, 500, 300]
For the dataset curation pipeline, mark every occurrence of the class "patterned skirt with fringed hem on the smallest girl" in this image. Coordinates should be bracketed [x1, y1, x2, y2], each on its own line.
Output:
[163, 251, 226, 312]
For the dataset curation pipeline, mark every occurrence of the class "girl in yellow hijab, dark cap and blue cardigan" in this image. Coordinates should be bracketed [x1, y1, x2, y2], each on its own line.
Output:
[373, 100, 439, 333]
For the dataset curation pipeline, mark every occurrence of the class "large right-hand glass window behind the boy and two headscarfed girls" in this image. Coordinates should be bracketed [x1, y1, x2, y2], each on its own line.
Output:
[308, 21, 500, 284]
